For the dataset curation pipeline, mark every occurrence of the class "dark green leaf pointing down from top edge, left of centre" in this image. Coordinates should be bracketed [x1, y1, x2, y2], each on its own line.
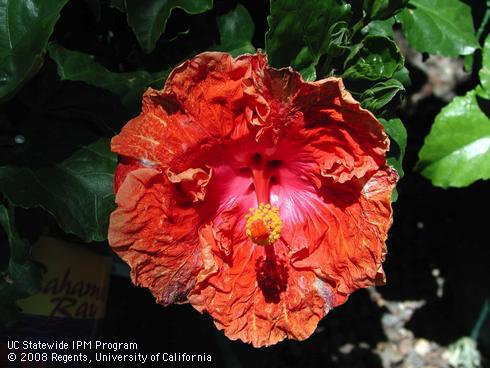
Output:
[122, 0, 213, 53]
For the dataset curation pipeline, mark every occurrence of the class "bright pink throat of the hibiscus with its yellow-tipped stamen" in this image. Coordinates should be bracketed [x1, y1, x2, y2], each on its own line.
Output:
[208, 140, 311, 246]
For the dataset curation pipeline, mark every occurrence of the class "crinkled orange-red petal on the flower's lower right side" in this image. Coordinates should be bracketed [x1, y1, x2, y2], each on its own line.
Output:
[291, 167, 398, 306]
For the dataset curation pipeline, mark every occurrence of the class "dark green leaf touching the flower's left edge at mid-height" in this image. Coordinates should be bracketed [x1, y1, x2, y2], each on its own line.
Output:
[0, 139, 117, 242]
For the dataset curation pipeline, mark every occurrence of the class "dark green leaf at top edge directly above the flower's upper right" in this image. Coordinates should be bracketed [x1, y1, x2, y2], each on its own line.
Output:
[265, 0, 351, 80]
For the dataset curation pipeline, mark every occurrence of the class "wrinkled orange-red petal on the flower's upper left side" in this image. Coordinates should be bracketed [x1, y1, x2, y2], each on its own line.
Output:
[111, 52, 264, 171]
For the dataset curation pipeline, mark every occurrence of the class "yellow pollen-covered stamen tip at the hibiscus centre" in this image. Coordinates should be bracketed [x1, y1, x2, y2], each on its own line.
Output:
[245, 203, 282, 245]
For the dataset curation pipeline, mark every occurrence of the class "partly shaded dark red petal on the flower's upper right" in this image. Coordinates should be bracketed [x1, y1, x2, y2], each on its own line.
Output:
[295, 78, 389, 183]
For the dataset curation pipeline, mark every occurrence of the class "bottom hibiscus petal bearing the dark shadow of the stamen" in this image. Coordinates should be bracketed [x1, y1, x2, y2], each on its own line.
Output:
[189, 239, 333, 347]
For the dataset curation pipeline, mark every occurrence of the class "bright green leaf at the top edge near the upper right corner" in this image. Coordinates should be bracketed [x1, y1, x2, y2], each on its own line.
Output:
[396, 0, 479, 56]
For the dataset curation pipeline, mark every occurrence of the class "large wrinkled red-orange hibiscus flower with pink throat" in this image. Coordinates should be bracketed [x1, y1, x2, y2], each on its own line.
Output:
[109, 52, 397, 347]
